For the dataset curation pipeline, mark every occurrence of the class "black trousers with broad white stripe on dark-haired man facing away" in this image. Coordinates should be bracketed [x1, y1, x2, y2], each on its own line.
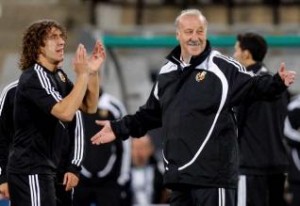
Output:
[238, 174, 286, 206]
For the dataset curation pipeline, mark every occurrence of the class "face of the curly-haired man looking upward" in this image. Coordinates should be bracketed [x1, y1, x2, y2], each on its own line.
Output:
[38, 27, 65, 70]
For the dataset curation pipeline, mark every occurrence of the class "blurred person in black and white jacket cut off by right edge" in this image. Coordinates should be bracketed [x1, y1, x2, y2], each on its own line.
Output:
[284, 95, 300, 206]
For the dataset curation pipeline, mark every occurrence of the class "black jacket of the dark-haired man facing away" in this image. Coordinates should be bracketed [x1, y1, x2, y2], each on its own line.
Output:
[237, 63, 288, 175]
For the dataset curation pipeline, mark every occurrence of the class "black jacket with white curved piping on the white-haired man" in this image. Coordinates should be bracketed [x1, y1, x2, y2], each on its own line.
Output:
[111, 42, 286, 188]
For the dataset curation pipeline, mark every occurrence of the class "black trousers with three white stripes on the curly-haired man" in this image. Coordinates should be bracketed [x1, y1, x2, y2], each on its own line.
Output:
[7, 174, 56, 206]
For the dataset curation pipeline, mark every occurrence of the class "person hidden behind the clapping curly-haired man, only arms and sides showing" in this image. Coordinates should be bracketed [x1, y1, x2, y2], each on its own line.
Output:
[0, 80, 85, 206]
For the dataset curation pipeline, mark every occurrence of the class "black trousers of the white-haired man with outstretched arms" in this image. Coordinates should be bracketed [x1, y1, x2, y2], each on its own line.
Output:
[170, 187, 236, 206]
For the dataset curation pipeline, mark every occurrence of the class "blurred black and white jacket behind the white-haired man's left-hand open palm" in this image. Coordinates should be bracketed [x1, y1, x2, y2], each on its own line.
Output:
[80, 92, 131, 187]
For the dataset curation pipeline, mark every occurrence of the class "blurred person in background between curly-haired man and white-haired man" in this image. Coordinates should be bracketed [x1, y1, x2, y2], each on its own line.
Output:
[74, 88, 131, 206]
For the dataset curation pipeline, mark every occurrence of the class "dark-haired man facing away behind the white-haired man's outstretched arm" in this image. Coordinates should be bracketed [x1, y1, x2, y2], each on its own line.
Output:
[234, 32, 289, 206]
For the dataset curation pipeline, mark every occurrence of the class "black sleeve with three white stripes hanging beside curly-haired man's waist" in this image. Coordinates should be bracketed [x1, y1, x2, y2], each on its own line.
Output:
[66, 111, 85, 176]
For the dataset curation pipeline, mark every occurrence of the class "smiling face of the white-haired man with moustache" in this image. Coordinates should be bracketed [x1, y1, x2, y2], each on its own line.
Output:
[176, 14, 207, 58]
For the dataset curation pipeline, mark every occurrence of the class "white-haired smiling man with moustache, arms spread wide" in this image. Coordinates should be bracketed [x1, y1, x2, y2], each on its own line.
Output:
[91, 9, 295, 206]
